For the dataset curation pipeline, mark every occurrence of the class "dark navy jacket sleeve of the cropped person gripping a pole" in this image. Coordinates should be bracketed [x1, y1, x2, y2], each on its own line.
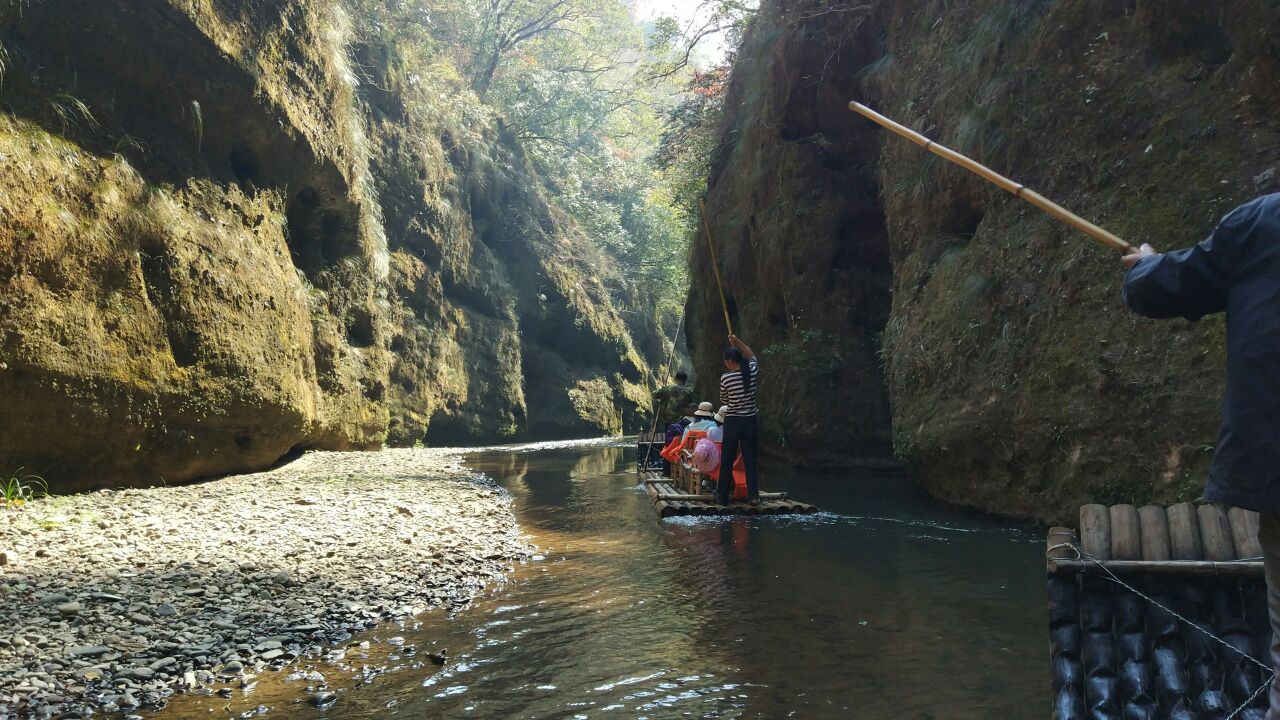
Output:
[1124, 213, 1239, 320]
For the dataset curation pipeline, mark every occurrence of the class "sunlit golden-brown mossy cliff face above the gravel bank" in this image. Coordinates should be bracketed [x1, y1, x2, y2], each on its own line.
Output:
[0, 0, 646, 489]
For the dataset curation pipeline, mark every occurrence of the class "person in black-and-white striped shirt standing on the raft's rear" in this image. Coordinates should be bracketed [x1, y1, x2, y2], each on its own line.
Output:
[716, 334, 760, 505]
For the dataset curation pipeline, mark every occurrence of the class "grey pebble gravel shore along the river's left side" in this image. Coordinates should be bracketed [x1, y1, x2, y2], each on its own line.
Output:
[0, 450, 531, 719]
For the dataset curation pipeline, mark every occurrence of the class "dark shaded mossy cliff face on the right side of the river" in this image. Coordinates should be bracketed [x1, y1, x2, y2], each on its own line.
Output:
[690, 0, 1280, 521]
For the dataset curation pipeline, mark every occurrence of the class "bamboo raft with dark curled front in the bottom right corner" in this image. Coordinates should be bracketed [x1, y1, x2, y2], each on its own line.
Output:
[1046, 502, 1271, 720]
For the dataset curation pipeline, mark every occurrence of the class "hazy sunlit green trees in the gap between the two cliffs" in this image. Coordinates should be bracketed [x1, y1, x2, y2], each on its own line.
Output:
[357, 0, 754, 326]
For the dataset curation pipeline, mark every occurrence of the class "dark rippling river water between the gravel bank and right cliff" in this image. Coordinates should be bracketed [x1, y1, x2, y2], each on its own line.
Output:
[162, 443, 1050, 720]
